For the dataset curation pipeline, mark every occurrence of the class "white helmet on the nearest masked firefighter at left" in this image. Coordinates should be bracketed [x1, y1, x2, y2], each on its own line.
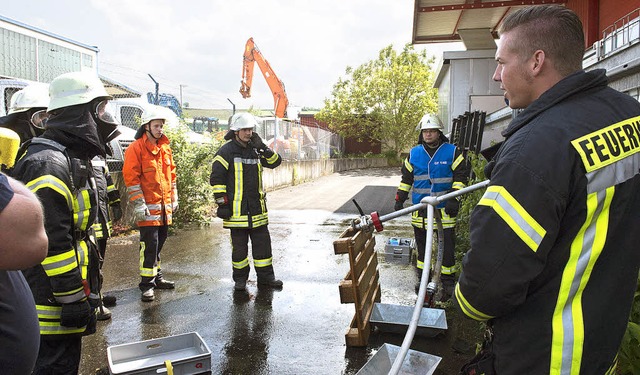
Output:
[47, 72, 111, 112]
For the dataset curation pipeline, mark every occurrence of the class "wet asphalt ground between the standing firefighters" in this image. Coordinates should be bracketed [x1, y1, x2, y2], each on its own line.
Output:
[80, 168, 464, 375]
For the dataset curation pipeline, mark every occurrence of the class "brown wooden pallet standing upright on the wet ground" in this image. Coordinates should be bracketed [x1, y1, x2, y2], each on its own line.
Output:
[333, 228, 381, 347]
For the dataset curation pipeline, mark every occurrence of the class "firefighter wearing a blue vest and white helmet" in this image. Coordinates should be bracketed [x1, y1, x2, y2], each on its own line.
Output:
[394, 114, 469, 301]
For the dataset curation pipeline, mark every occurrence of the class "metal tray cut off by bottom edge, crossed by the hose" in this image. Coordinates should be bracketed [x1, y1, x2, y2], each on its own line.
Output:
[356, 344, 442, 375]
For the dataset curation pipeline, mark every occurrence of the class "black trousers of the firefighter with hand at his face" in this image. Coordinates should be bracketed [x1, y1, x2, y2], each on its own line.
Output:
[231, 225, 275, 282]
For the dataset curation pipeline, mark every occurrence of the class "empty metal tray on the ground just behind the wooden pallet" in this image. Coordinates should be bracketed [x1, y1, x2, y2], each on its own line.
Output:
[369, 303, 447, 337]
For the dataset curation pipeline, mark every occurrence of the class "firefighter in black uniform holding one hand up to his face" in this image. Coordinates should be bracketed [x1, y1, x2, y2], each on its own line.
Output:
[209, 113, 282, 291]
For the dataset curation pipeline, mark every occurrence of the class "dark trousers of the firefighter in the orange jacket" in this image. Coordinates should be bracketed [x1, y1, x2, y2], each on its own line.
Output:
[138, 225, 169, 292]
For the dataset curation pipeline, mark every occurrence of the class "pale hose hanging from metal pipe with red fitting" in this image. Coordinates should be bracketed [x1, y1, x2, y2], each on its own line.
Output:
[352, 180, 489, 375]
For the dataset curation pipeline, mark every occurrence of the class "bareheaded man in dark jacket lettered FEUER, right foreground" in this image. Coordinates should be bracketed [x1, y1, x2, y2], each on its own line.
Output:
[455, 5, 640, 375]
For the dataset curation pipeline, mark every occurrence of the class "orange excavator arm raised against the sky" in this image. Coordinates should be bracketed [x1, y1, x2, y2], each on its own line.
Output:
[240, 38, 289, 118]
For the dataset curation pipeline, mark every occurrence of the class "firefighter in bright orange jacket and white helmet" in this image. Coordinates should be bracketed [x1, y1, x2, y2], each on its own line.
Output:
[122, 110, 178, 302]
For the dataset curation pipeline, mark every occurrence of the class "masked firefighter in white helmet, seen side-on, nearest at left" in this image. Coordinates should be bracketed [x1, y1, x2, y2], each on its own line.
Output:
[12, 72, 119, 374]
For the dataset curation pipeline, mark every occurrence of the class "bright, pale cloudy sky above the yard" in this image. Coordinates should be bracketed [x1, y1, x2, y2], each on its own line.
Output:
[0, 0, 463, 109]
